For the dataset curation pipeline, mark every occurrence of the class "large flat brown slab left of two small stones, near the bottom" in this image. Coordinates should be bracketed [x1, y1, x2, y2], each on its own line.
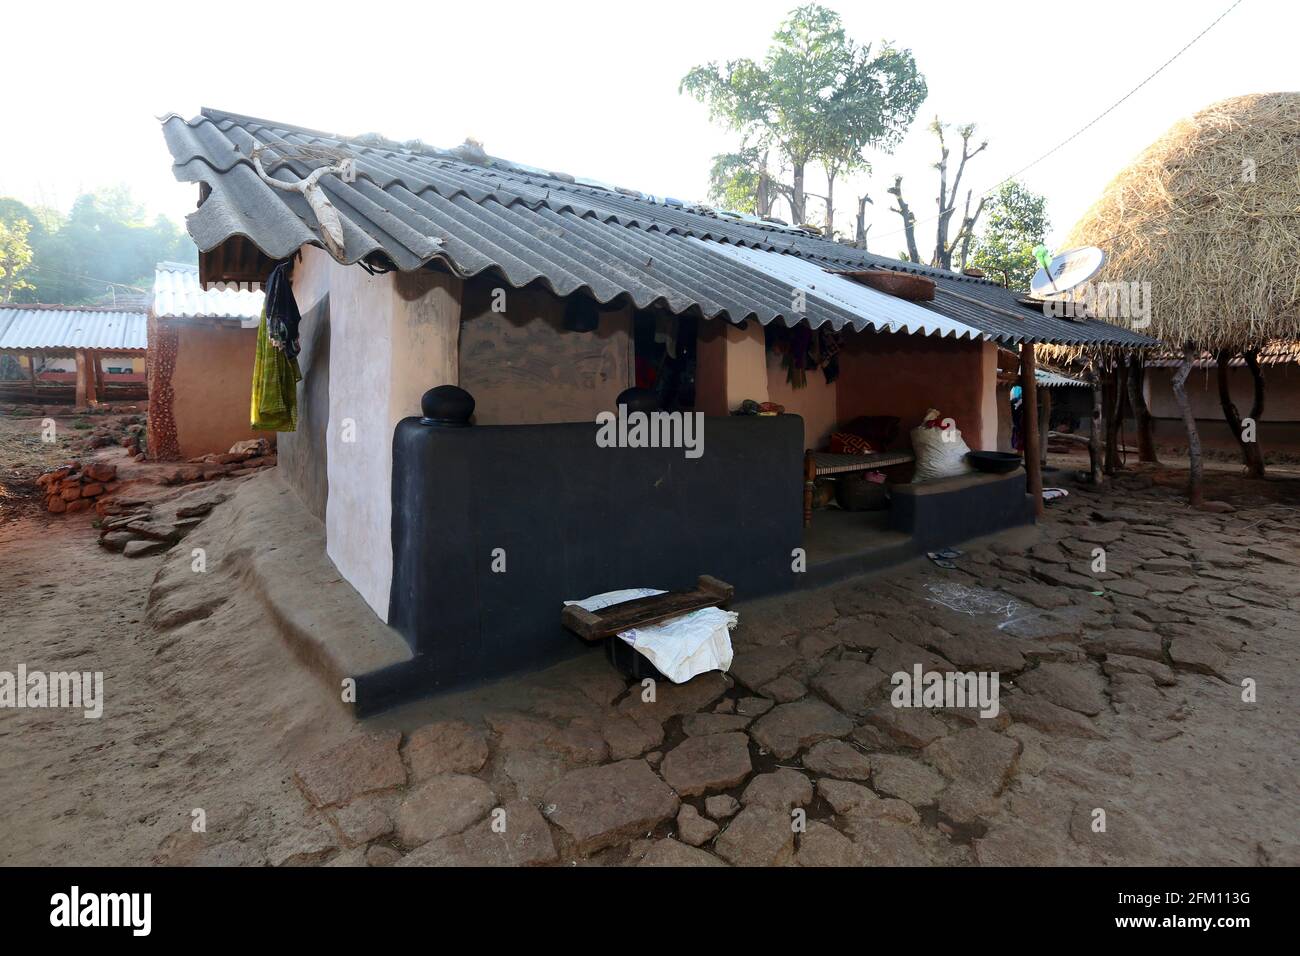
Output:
[545, 759, 681, 855]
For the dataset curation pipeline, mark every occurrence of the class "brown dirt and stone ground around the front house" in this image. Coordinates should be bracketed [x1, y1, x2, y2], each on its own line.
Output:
[0, 411, 1300, 865]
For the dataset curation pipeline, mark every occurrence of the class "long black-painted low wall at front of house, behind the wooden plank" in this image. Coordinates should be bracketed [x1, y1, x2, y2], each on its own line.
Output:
[377, 415, 803, 708]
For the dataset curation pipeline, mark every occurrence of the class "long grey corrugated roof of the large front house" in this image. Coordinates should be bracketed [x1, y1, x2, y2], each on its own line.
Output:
[163, 109, 1153, 347]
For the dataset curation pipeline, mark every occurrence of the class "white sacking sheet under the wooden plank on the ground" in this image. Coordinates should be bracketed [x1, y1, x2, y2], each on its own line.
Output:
[564, 588, 740, 684]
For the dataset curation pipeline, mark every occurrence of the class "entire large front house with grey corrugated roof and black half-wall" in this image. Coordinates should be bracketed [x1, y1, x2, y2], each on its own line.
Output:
[163, 109, 1148, 709]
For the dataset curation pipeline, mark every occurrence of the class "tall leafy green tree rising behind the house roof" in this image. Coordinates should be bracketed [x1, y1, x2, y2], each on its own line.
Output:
[680, 4, 927, 222]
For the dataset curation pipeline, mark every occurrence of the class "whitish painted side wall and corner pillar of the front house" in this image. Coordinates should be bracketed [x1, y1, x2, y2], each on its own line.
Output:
[295, 247, 462, 620]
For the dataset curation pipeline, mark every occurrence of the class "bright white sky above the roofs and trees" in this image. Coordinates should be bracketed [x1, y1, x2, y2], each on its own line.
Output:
[0, 0, 1300, 255]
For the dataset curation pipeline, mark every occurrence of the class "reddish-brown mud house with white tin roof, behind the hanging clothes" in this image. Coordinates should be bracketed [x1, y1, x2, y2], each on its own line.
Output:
[148, 263, 264, 460]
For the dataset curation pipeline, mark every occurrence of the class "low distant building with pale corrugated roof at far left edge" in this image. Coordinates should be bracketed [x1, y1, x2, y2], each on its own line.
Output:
[0, 306, 148, 408]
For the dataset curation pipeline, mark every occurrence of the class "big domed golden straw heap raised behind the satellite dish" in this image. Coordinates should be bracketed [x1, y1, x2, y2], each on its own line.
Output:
[1067, 92, 1300, 350]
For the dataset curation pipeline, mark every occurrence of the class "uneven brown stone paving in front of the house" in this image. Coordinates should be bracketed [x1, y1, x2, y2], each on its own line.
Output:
[298, 475, 1300, 866]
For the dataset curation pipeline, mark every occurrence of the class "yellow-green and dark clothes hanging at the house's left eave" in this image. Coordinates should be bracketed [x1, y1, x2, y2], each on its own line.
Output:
[248, 263, 303, 432]
